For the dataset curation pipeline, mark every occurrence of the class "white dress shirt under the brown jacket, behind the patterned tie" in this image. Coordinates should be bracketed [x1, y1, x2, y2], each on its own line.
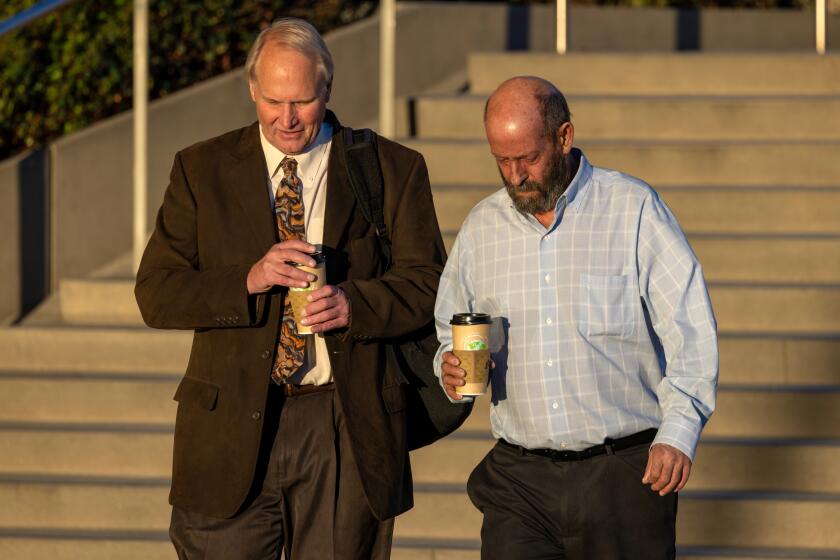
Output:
[260, 123, 332, 385]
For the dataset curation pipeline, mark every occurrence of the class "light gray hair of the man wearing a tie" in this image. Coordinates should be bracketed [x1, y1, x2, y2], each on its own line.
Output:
[245, 17, 333, 89]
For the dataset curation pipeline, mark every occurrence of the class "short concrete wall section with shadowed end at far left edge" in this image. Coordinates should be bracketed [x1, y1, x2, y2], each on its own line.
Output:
[0, 150, 49, 325]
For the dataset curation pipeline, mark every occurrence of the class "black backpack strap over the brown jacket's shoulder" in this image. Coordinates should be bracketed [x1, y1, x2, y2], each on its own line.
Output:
[344, 127, 391, 266]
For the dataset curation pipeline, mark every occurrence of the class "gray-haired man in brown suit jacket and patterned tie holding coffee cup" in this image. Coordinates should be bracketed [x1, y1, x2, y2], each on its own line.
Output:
[135, 18, 445, 560]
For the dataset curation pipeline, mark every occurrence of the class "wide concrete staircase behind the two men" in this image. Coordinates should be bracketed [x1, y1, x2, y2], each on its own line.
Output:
[0, 54, 840, 560]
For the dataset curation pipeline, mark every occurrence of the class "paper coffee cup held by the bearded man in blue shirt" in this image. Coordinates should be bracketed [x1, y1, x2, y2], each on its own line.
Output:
[449, 313, 492, 396]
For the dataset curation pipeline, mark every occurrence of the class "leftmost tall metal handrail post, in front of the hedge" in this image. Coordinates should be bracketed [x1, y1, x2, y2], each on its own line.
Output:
[133, 0, 149, 272]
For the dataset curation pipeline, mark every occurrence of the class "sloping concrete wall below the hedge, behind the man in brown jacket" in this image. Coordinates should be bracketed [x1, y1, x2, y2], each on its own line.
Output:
[50, 4, 540, 281]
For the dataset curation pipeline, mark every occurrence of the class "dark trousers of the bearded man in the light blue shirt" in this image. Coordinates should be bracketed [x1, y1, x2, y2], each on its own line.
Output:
[467, 444, 677, 560]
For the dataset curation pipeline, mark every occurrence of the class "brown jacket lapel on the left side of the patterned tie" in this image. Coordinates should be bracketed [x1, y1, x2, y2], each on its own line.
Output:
[228, 123, 277, 254]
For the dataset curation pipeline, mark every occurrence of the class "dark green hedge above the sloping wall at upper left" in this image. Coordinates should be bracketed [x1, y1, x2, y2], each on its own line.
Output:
[0, 0, 375, 159]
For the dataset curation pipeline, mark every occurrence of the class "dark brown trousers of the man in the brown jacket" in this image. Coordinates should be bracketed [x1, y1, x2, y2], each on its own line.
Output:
[169, 390, 393, 560]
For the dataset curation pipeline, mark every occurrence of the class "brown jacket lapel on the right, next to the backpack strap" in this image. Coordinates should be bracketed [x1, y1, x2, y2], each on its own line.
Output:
[324, 111, 356, 248]
